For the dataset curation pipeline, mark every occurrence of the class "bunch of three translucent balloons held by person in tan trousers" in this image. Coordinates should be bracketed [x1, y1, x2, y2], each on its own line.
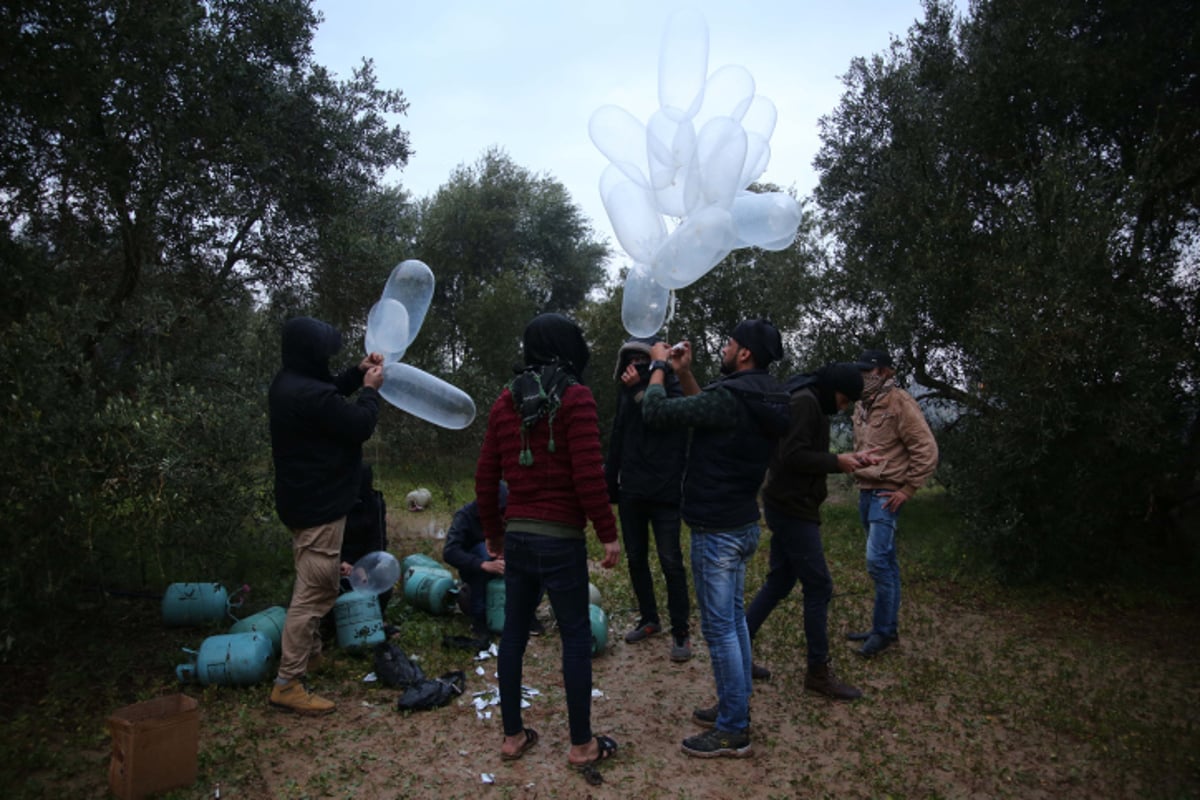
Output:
[365, 259, 475, 431]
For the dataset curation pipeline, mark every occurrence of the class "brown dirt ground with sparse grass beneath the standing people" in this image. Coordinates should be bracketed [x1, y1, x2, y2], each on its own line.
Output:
[213, 513, 1200, 800]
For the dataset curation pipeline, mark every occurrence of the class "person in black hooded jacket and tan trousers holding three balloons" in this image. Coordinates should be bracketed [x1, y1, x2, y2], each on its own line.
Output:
[268, 317, 383, 715]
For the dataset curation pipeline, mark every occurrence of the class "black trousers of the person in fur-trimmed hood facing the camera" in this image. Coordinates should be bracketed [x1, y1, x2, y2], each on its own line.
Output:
[618, 499, 691, 637]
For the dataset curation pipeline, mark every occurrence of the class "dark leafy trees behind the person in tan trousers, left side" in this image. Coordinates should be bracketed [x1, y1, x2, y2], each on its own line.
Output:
[0, 0, 410, 646]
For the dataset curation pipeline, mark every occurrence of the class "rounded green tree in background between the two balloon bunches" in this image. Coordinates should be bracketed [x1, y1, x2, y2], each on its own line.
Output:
[404, 149, 606, 450]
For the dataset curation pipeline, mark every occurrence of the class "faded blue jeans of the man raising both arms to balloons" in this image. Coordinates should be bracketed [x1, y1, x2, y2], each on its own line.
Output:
[691, 523, 760, 733]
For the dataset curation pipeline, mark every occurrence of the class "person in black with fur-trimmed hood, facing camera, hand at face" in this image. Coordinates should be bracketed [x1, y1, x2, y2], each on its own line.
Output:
[605, 336, 691, 662]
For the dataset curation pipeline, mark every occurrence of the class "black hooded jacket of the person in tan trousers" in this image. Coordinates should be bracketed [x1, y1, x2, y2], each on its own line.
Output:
[268, 317, 379, 529]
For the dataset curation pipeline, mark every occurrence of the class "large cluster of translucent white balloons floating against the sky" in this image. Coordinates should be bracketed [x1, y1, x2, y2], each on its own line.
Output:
[588, 12, 800, 336]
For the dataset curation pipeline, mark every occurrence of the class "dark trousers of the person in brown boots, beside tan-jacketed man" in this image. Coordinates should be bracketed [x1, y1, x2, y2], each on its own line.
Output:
[746, 506, 833, 666]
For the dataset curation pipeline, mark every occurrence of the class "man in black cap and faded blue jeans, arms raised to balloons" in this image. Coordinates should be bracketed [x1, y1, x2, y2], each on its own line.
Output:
[642, 319, 790, 758]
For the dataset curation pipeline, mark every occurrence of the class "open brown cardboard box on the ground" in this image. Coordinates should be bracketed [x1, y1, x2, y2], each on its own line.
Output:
[108, 694, 200, 800]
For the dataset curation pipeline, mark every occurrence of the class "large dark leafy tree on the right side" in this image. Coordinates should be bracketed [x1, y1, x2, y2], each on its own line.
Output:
[817, 0, 1200, 579]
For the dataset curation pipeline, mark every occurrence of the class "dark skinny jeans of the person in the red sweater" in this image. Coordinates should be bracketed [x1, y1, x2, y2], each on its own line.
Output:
[497, 528, 592, 745]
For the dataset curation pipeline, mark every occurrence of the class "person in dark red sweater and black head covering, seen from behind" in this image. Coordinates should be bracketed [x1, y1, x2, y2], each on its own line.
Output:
[475, 313, 620, 783]
